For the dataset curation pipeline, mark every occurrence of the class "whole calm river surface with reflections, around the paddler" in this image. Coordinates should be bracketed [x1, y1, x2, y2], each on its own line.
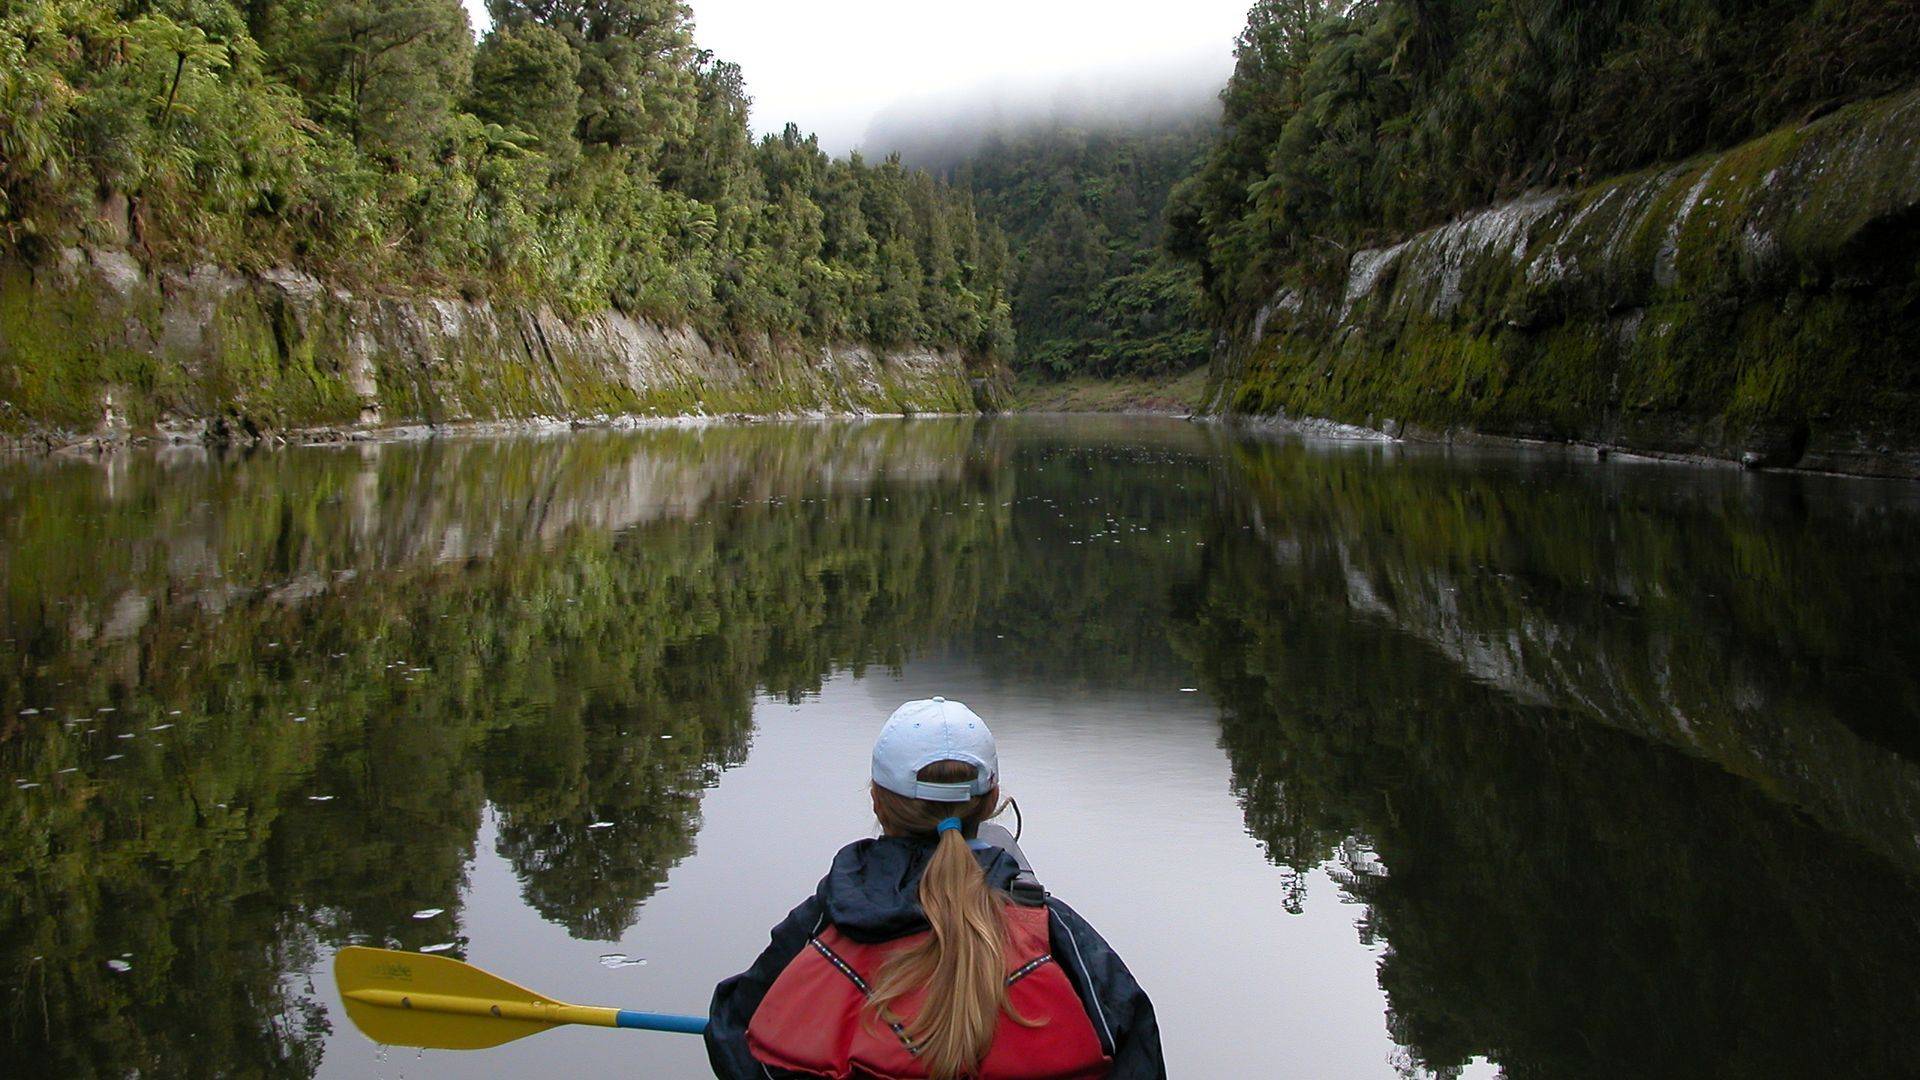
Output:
[0, 419, 1920, 1078]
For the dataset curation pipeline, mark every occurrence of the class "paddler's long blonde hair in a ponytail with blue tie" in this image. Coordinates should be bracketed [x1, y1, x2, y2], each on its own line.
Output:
[868, 761, 1041, 1080]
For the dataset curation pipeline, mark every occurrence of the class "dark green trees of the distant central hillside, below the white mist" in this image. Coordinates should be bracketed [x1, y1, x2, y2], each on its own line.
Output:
[947, 119, 1213, 377]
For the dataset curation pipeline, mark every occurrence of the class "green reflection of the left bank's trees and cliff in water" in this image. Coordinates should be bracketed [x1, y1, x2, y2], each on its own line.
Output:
[0, 425, 1002, 1076]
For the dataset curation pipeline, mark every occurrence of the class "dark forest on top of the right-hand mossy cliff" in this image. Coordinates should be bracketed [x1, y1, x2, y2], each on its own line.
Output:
[1169, 0, 1920, 317]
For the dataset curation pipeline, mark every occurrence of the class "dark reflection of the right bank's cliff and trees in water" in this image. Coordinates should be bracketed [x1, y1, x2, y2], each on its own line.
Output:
[1183, 444, 1920, 1076]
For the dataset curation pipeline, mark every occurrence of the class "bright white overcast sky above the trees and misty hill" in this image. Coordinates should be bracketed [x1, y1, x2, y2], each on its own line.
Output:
[467, 0, 1252, 154]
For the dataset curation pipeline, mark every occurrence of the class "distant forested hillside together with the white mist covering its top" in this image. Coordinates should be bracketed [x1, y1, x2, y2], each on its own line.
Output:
[866, 60, 1225, 379]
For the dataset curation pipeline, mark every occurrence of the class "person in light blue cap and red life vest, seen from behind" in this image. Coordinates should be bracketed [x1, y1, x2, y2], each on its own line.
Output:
[707, 698, 1167, 1080]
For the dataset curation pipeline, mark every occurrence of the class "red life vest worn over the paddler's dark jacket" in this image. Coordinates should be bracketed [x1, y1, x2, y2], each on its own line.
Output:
[747, 903, 1112, 1080]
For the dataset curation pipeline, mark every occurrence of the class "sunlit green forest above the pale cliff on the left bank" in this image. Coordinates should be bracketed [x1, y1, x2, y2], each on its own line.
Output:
[0, 0, 1012, 357]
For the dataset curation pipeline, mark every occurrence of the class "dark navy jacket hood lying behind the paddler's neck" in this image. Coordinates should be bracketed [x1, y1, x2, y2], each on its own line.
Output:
[814, 836, 1020, 942]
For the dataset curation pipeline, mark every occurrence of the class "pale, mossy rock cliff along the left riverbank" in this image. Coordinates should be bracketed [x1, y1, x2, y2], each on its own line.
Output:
[0, 250, 991, 444]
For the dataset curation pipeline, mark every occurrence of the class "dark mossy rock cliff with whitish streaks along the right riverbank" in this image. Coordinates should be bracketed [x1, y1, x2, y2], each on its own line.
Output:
[1212, 90, 1920, 477]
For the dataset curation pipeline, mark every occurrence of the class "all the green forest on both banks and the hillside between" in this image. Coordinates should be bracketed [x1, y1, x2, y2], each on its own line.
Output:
[0, 0, 1920, 407]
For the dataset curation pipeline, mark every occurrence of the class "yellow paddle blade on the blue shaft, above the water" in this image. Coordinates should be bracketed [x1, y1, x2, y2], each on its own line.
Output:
[334, 945, 572, 1049]
